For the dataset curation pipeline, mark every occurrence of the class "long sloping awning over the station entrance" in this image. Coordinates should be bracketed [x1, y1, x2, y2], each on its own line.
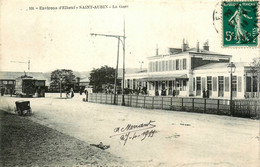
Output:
[136, 74, 188, 82]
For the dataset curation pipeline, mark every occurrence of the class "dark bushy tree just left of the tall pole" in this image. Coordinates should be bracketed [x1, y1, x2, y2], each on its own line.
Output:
[89, 66, 120, 92]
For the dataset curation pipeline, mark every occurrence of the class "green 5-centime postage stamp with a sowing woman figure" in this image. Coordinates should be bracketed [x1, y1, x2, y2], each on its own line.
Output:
[222, 1, 259, 47]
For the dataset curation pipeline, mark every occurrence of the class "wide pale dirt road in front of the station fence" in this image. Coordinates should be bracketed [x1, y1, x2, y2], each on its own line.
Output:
[0, 94, 260, 167]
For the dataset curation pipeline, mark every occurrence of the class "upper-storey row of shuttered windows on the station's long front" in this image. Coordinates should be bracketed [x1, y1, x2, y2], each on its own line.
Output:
[148, 59, 187, 72]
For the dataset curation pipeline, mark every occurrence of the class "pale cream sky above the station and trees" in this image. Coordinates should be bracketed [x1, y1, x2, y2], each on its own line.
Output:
[0, 0, 260, 72]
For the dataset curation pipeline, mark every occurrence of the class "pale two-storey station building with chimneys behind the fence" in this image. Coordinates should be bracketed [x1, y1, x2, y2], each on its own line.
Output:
[125, 41, 259, 99]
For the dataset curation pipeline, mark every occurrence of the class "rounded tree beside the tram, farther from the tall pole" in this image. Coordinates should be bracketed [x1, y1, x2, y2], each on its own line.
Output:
[50, 69, 75, 91]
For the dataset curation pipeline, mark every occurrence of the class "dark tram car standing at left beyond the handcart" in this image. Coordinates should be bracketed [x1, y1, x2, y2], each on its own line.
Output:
[15, 75, 45, 97]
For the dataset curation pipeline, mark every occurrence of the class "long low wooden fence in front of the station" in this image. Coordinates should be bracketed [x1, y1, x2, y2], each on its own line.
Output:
[88, 93, 260, 117]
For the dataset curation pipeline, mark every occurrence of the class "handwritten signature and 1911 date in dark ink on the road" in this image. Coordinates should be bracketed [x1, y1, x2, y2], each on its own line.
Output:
[110, 120, 158, 145]
